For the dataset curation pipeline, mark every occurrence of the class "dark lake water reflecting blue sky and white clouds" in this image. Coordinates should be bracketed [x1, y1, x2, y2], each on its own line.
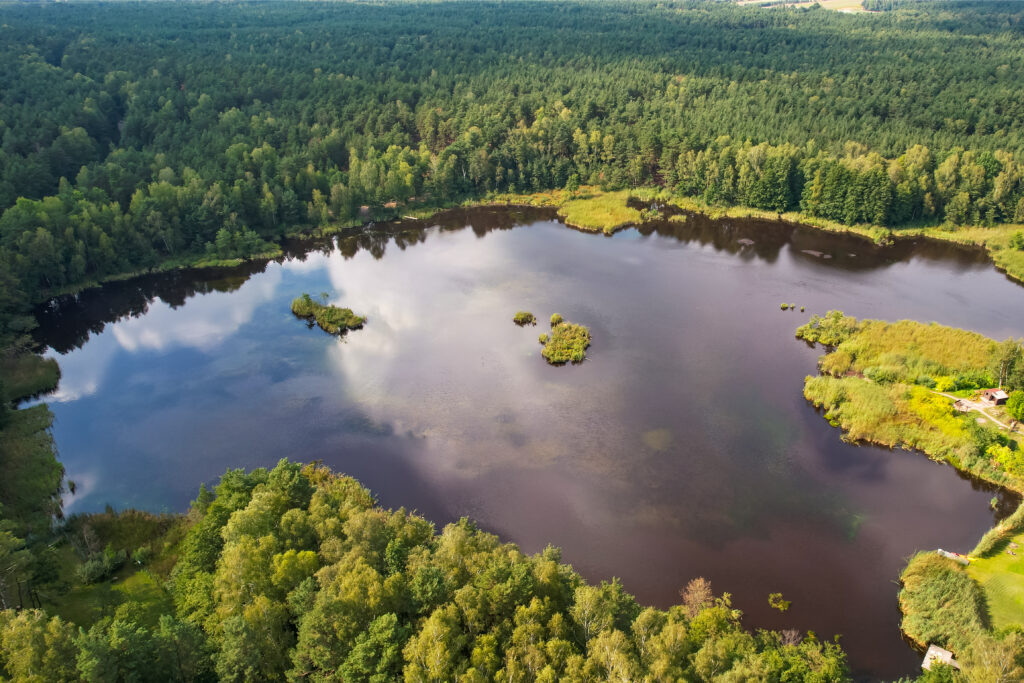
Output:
[29, 210, 1024, 678]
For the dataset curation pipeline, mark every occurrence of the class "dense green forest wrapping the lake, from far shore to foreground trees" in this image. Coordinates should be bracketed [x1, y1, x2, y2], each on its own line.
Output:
[0, 0, 1024, 683]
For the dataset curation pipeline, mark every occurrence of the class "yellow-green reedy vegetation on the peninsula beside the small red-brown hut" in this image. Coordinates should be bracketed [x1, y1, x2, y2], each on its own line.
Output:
[797, 311, 1024, 490]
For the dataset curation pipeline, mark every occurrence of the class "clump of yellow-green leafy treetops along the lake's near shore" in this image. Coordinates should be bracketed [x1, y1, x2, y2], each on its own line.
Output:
[165, 461, 846, 683]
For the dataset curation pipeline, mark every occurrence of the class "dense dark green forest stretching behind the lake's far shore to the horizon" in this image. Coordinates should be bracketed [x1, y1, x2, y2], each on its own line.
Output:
[0, 2, 1024, 348]
